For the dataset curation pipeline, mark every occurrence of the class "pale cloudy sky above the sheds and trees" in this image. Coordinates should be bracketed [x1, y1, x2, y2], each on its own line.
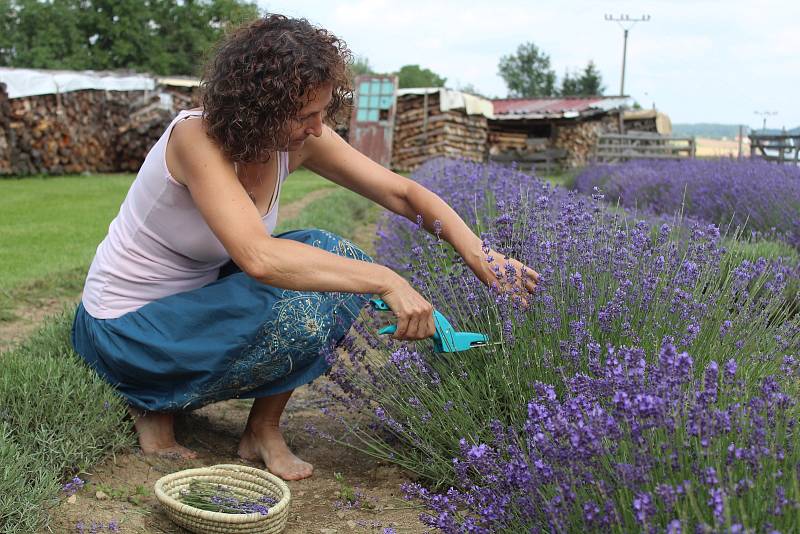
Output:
[258, 0, 800, 128]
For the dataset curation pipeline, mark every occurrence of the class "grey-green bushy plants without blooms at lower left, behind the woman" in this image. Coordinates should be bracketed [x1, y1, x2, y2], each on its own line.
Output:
[0, 312, 133, 533]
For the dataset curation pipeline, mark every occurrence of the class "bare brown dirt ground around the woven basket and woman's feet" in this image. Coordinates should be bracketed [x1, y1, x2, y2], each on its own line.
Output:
[40, 378, 429, 534]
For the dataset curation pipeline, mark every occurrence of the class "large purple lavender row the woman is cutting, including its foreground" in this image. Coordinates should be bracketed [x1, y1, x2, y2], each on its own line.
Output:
[318, 160, 800, 532]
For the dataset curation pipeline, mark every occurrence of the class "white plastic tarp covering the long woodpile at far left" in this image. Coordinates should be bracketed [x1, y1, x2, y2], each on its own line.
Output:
[0, 67, 156, 98]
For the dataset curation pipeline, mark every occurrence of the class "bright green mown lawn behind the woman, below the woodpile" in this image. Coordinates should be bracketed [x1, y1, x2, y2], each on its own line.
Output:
[0, 169, 336, 321]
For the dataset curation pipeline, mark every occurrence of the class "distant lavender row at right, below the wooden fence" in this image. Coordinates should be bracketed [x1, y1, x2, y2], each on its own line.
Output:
[575, 159, 800, 247]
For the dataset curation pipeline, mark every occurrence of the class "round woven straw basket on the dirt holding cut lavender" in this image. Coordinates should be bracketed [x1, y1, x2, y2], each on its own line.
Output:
[155, 464, 291, 534]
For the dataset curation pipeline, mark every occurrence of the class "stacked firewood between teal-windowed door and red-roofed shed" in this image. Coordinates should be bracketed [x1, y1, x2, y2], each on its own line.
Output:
[392, 93, 488, 171]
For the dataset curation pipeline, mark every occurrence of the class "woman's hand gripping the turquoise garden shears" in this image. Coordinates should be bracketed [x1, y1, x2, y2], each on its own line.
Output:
[381, 276, 436, 340]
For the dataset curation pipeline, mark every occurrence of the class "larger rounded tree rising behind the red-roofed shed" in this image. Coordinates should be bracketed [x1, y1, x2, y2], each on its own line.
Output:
[498, 42, 556, 97]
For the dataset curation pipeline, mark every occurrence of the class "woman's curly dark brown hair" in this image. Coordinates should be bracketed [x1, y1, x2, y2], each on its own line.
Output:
[201, 14, 353, 163]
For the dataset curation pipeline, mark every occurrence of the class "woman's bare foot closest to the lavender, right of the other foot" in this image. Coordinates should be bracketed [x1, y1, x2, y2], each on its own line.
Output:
[239, 425, 314, 480]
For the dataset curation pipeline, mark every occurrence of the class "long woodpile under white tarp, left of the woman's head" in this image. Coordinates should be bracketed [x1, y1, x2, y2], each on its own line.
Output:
[0, 84, 196, 175]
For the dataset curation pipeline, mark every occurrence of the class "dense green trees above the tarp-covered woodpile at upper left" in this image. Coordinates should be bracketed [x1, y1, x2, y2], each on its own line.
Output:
[0, 0, 259, 75]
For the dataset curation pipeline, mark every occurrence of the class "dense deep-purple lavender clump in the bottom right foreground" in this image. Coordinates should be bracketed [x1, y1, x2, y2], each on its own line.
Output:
[404, 341, 800, 534]
